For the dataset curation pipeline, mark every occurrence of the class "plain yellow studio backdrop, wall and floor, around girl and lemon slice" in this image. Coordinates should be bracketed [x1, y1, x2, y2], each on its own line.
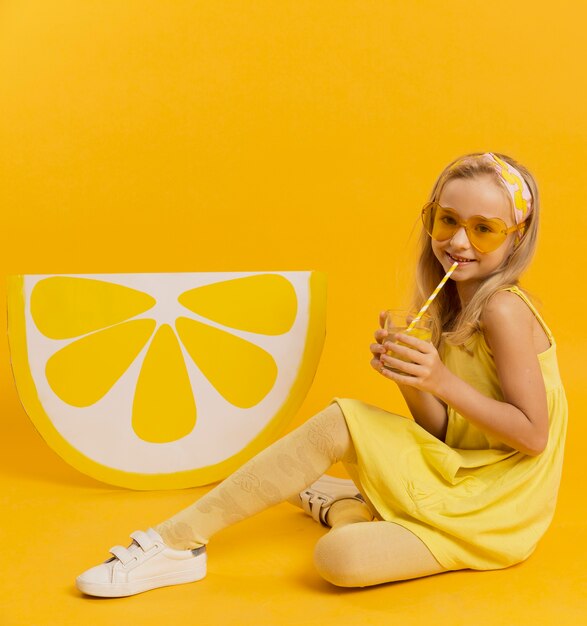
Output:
[0, 0, 587, 625]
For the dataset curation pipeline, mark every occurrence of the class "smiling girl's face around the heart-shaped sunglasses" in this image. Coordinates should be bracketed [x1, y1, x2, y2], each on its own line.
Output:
[431, 175, 517, 300]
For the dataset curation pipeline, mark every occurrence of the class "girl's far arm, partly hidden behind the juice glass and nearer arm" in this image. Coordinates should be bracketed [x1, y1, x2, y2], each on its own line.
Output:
[371, 311, 448, 441]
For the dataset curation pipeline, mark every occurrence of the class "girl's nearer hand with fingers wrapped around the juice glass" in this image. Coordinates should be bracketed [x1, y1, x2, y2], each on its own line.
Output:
[380, 333, 448, 395]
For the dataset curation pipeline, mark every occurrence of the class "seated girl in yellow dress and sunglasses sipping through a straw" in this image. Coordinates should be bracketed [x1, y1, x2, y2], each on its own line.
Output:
[76, 153, 567, 597]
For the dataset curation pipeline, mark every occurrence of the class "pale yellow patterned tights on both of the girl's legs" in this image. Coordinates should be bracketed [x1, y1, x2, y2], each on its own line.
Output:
[154, 404, 446, 587]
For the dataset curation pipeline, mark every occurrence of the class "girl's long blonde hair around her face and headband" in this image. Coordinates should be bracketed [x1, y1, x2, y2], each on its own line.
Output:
[413, 152, 540, 347]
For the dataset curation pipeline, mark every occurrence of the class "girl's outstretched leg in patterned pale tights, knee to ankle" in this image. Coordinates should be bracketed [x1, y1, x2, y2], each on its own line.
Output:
[154, 404, 356, 550]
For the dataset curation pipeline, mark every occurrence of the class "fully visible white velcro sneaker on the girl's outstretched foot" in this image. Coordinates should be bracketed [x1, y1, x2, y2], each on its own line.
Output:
[75, 528, 206, 598]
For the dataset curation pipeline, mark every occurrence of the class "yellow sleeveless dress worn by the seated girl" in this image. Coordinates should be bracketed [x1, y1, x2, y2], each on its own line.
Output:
[332, 287, 568, 570]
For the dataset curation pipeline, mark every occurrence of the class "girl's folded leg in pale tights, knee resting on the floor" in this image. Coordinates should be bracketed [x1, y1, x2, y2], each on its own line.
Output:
[314, 520, 449, 587]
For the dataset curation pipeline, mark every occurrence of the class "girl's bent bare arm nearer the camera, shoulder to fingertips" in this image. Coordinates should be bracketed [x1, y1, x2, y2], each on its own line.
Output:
[381, 291, 548, 456]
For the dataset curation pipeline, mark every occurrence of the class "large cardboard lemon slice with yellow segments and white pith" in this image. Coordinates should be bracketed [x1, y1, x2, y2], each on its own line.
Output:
[8, 272, 326, 489]
